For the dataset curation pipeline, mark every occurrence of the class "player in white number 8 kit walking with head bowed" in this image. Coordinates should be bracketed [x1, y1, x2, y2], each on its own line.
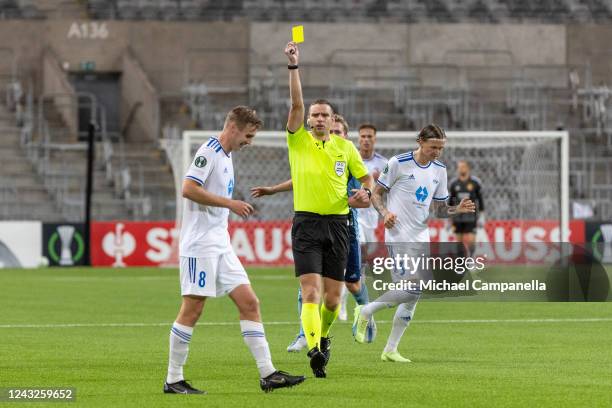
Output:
[164, 106, 304, 394]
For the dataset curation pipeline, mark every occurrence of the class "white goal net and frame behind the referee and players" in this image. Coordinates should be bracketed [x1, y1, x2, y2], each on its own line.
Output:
[164, 131, 569, 262]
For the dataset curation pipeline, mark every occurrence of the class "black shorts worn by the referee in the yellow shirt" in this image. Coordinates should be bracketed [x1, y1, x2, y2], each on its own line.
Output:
[291, 211, 349, 281]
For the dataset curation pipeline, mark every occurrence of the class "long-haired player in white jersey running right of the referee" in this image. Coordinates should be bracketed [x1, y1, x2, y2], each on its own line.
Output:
[354, 124, 475, 362]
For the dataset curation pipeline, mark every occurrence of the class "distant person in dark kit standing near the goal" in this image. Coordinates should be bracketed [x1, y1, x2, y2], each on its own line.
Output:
[448, 160, 484, 254]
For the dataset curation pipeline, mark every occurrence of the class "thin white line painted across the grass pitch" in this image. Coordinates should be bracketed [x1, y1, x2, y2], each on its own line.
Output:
[0, 317, 612, 329]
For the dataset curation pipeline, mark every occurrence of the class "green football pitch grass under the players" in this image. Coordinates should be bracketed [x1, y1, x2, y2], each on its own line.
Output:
[0, 268, 612, 408]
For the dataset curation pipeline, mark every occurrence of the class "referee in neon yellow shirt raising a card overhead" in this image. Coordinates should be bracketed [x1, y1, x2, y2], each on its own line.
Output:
[285, 42, 373, 377]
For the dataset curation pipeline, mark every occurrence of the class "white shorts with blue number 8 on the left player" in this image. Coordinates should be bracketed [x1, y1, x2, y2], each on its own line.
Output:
[180, 251, 251, 297]
